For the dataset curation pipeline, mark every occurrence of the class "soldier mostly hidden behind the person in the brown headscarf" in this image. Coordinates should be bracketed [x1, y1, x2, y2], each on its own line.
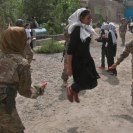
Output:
[16, 19, 33, 64]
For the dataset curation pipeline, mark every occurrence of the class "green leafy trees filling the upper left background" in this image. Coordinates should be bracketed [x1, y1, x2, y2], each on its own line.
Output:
[0, 0, 80, 34]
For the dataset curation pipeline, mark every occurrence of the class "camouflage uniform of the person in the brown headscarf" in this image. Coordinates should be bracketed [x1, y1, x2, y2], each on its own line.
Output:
[0, 52, 31, 133]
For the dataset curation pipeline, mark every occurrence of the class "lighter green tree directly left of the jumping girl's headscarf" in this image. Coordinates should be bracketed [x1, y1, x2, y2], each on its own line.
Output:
[48, 0, 80, 33]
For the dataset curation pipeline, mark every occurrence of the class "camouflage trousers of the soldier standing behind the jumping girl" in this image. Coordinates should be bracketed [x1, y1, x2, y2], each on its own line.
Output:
[61, 54, 68, 82]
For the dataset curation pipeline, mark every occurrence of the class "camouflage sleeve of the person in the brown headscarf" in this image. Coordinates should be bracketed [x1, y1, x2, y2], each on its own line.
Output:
[18, 65, 31, 98]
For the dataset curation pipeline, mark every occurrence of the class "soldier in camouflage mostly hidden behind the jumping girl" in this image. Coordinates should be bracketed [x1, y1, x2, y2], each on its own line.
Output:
[61, 25, 70, 87]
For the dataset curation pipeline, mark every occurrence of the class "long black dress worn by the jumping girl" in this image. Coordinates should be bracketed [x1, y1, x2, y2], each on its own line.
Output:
[67, 26, 99, 92]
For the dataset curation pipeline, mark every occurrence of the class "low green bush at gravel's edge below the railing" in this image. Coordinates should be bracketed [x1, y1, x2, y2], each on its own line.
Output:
[35, 40, 64, 54]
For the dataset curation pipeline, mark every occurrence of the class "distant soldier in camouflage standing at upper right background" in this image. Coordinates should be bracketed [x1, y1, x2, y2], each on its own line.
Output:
[119, 18, 128, 46]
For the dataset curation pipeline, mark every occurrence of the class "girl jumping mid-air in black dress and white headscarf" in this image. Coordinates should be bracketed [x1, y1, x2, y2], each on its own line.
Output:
[67, 8, 99, 103]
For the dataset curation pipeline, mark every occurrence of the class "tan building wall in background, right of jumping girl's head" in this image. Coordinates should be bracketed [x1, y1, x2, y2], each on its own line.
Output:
[80, 0, 124, 22]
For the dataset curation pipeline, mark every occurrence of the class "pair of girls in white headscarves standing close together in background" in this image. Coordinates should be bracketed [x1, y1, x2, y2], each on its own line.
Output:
[96, 22, 117, 76]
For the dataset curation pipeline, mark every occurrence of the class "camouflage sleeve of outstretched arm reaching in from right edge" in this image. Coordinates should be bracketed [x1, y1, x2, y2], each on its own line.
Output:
[115, 40, 133, 65]
